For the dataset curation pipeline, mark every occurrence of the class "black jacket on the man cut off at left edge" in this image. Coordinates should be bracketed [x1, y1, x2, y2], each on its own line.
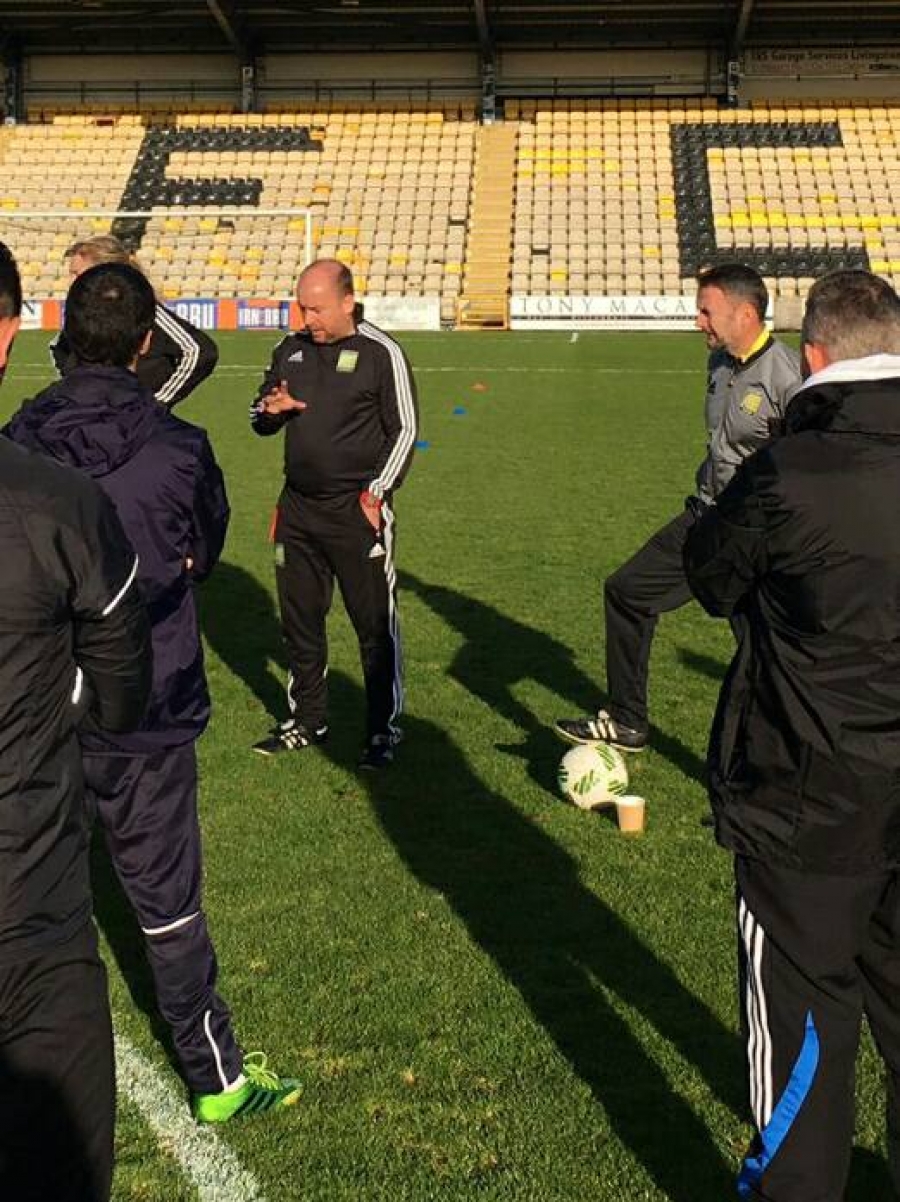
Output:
[0, 438, 151, 963]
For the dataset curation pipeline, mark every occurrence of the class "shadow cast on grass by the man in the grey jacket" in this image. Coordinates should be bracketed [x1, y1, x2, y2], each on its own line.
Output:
[398, 572, 711, 792]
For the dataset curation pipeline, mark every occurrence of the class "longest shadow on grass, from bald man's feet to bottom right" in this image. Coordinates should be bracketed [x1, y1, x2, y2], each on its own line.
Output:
[332, 673, 743, 1202]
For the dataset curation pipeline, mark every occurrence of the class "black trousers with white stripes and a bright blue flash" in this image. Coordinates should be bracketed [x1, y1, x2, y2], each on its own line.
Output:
[735, 857, 900, 1202]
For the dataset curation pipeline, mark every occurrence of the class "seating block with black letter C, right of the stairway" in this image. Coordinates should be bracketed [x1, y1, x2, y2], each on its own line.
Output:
[512, 100, 900, 305]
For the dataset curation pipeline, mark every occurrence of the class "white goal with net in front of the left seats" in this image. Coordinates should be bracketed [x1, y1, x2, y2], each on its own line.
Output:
[0, 206, 317, 301]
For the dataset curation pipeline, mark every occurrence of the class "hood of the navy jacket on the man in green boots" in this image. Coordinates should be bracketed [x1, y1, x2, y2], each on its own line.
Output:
[6, 367, 165, 477]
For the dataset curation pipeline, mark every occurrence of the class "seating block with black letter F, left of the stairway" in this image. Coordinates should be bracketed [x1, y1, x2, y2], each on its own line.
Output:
[0, 103, 478, 321]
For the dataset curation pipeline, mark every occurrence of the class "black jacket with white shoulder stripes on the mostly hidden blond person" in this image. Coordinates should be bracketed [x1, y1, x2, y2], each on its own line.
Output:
[50, 304, 219, 409]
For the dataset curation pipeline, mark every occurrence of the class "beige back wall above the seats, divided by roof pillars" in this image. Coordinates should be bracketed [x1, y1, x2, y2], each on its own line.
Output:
[12, 46, 900, 105]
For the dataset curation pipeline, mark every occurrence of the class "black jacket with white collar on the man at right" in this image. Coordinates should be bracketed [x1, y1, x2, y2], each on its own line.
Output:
[685, 355, 900, 874]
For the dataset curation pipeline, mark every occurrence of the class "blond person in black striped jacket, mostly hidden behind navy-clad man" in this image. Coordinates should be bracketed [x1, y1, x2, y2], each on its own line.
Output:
[50, 233, 219, 409]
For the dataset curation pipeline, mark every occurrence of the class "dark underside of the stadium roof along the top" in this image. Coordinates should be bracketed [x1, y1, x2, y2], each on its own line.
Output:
[0, 0, 900, 54]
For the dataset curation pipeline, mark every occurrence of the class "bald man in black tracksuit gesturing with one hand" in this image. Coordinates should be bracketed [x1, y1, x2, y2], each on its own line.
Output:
[251, 260, 417, 768]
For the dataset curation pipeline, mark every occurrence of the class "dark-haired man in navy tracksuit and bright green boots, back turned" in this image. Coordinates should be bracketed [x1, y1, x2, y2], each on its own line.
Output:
[8, 263, 297, 1121]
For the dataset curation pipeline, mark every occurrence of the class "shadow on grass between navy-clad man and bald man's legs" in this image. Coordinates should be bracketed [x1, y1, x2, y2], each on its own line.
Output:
[197, 561, 287, 721]
